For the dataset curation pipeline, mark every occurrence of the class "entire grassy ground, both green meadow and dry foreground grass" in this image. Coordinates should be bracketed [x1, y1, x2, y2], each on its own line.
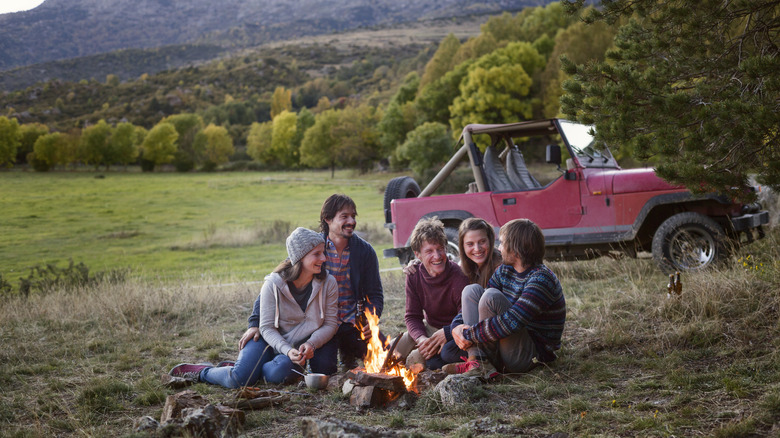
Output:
[0, 169, 780, 438]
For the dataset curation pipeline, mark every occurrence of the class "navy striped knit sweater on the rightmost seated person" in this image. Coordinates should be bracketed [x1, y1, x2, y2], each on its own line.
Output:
[452, 264, 566, 362]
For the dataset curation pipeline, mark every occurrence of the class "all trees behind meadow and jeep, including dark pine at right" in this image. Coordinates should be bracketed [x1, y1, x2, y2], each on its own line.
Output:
[0, 0, 780, 192]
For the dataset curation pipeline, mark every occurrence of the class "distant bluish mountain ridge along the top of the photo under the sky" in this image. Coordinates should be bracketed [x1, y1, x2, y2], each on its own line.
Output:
[0, 0, 550, 71]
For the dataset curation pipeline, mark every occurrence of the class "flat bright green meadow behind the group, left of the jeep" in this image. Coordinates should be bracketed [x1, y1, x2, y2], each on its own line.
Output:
[0, 171, 394, 284]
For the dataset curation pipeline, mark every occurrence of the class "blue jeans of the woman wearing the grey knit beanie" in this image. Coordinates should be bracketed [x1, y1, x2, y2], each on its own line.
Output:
[200, 337, 336, 388]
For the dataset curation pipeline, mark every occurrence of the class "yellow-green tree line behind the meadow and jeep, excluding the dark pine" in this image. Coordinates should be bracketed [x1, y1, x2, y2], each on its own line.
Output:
[0, 3, 615, 176]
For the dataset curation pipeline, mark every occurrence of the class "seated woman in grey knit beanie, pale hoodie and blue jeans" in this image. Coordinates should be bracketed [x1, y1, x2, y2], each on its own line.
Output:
[169, 228, 338, 388]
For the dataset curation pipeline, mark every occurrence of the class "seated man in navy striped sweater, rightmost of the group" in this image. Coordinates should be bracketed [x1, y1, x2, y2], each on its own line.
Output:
[444, 219, 566, 378]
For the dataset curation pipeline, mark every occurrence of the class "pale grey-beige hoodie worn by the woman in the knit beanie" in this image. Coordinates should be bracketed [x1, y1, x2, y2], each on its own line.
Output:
[249, 273, 339, 355]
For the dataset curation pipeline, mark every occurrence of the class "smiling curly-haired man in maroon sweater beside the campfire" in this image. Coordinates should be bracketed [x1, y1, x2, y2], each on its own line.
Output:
[395, 218, 469, 369]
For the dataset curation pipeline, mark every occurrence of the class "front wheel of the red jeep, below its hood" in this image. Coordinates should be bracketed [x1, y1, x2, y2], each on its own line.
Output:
[653, 212, 728, 273]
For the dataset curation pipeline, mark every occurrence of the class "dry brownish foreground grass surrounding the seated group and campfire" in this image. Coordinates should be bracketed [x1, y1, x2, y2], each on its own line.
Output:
[0, 218, 780, 437]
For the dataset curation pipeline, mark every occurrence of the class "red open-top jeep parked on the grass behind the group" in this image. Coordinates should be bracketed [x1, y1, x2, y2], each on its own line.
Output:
[384, 119, 769, 271]
